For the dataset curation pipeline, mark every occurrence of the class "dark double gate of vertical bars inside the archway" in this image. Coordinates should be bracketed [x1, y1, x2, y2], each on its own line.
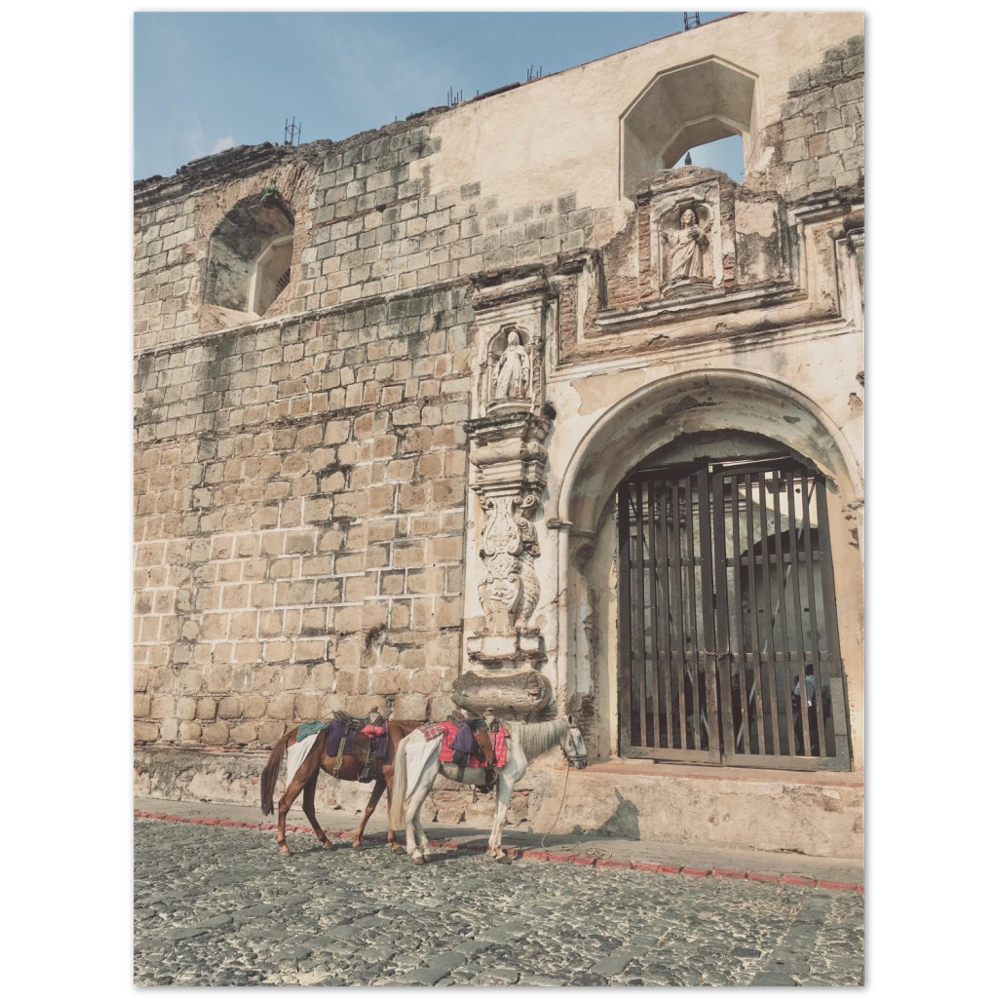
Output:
[618, 458, 850, 770]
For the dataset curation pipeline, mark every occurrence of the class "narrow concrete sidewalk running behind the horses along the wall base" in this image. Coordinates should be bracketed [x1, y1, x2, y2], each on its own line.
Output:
[132, 799, 865, 892]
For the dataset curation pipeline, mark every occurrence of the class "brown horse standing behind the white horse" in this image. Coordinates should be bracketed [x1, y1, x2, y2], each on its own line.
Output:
[260, 719, 424, 854]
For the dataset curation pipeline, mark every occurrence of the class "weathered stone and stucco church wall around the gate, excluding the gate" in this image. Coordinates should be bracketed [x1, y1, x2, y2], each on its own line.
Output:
[134, 11, 864, 853]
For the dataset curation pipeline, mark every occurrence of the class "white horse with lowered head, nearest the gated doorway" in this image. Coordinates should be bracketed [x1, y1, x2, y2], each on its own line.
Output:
[389, 717, 587, 865]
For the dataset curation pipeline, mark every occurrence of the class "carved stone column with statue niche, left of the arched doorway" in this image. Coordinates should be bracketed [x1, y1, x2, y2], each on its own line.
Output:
[452, 268, 552, 718]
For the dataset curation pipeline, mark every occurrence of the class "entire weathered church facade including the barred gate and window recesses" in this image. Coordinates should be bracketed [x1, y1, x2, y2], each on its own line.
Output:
[133, 11, 865, 857]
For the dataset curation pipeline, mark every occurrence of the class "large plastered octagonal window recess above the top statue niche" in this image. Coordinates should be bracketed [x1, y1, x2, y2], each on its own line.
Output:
[622, 57, 756, 198]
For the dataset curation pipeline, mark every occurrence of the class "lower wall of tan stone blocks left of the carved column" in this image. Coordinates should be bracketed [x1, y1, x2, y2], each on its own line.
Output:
[134, 288, 470, 746]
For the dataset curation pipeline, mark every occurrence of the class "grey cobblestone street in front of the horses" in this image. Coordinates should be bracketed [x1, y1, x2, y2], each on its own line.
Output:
[133, 819, 865, 986]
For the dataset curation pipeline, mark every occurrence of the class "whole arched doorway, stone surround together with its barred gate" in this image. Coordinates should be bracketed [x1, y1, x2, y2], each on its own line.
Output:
[555, 370, 865, 770]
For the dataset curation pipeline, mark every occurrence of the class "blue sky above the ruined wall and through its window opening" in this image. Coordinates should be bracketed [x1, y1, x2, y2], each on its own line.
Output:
[132, 11, 742, 180]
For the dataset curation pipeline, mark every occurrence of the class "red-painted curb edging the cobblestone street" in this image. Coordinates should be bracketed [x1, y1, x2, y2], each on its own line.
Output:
[132, 809, 865, 893]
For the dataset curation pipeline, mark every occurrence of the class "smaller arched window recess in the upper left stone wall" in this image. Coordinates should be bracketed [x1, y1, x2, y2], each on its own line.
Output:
[205, 194, 295, 317]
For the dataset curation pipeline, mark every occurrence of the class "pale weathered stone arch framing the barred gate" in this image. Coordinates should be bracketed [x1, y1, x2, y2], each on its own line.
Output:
[558, 371, 864, 767]
